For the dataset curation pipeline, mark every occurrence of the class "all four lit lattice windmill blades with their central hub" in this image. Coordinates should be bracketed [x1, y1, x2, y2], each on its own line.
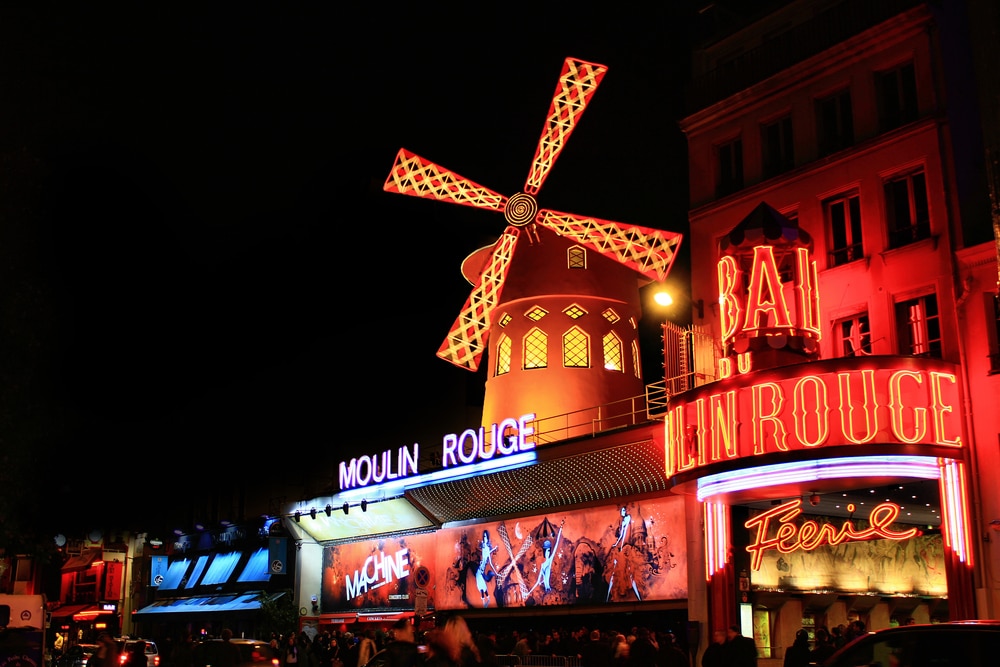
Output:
[383, 58, 681, 371]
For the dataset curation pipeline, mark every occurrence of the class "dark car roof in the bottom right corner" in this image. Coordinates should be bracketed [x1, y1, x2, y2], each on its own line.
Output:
[822, 621, 1000, 667]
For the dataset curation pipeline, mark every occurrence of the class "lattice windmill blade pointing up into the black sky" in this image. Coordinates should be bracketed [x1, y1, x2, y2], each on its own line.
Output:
[524, 58, 608, 195]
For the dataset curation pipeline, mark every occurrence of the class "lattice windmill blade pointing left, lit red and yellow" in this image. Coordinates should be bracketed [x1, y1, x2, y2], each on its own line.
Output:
[382, 148, 507, 211]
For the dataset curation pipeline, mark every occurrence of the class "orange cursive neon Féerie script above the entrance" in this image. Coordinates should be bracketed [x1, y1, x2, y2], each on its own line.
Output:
[743, 498, 917, 570]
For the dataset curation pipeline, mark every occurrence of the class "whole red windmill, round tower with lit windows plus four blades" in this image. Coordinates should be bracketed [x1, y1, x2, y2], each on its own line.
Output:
[383, 58, 681, 442]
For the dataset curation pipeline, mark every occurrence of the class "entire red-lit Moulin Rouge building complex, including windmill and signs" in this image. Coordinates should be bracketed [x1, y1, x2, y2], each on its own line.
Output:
[148, 0, 1000, 664]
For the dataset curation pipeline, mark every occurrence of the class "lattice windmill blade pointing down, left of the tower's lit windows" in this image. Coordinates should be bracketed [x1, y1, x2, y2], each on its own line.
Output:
[437, 226, 520, 371]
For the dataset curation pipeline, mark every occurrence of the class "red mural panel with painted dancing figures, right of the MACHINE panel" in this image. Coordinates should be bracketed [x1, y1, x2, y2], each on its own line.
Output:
[435, 497, 687, 609]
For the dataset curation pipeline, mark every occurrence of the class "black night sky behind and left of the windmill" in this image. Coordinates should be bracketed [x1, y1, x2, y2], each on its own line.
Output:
[0, 2, 720, 536]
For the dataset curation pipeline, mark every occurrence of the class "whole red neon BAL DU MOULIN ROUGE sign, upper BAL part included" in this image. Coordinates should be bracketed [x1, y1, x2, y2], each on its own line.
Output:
[665, 246, 962, 476]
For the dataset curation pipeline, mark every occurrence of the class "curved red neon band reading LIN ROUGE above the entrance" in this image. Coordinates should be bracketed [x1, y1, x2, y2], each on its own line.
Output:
[665, 357, 962, 476]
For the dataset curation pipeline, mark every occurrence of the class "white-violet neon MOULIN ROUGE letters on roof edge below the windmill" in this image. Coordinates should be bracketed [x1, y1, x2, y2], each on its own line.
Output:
[340, 412, 535, 491]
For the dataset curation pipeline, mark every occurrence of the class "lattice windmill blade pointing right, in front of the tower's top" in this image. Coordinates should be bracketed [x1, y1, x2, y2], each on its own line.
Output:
[536, 209, 681, 281]
